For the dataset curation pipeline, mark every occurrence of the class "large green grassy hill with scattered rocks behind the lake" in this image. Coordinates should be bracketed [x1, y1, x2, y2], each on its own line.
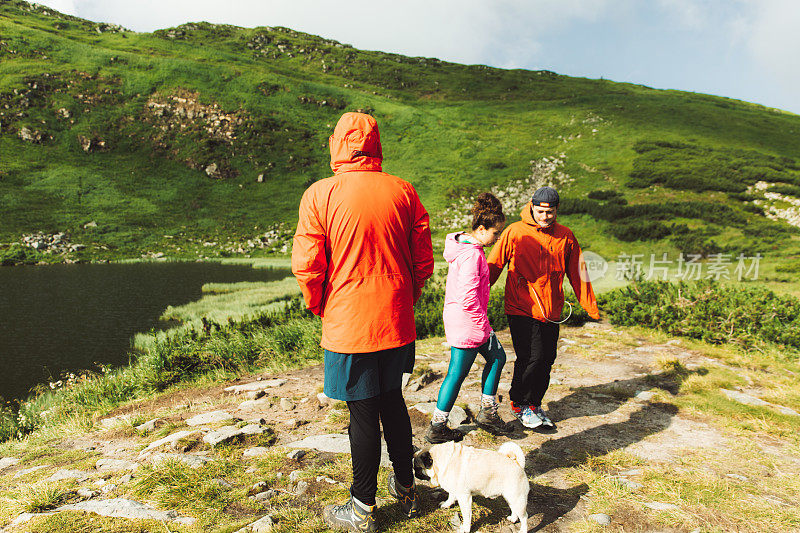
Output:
[0, 0, 800, 274]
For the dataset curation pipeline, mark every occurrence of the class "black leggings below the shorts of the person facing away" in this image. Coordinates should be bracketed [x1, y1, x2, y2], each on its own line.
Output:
[347, 389, 414, 505]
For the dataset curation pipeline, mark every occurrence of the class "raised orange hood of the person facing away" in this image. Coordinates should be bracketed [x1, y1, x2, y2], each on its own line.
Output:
[329, 113, 383, 174]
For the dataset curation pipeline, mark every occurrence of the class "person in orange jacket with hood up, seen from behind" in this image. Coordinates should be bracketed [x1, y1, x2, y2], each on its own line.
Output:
[292, 113, 433, 531]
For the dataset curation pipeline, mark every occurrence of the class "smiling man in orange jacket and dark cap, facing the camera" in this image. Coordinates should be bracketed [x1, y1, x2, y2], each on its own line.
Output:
[487, 187, 600, 429]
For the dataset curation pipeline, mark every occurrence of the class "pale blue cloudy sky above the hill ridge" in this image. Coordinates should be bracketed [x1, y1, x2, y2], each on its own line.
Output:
[34, 0, 800, 114]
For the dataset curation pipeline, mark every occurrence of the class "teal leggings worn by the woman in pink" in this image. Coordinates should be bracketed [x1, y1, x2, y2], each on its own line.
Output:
[436, 333, 506, 413]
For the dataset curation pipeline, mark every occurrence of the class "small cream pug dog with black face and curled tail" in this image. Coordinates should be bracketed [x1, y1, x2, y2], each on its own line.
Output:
[414, 441, 530, 533]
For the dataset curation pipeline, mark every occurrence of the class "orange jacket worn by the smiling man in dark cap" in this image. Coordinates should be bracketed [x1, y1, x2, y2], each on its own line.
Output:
[487, 202, 600, 322]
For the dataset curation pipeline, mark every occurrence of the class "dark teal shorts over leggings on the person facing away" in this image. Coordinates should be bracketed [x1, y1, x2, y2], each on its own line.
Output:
[324, 342, 416, 402]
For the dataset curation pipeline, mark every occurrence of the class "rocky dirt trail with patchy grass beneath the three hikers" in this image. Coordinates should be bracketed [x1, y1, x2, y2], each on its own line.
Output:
[0, 323, 800, 532]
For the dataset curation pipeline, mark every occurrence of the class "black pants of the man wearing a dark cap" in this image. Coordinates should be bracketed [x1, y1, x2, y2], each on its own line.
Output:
[508, 315, 559, 407]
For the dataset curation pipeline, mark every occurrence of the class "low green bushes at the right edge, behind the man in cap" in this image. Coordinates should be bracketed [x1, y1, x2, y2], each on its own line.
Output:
[599, 280, 800, 359]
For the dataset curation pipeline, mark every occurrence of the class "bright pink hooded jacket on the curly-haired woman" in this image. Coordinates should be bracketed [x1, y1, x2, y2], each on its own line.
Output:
[443, 233, 492, 348]
